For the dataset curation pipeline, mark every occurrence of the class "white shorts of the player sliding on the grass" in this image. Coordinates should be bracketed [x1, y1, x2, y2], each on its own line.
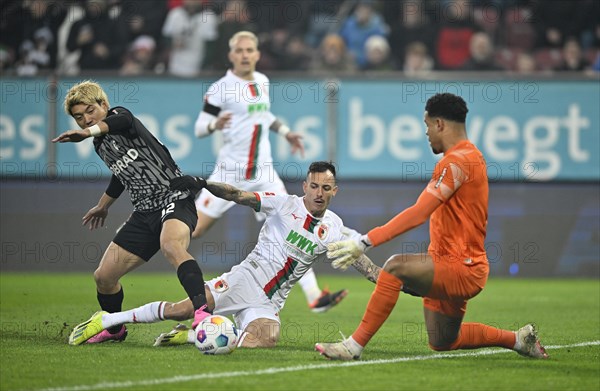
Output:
[206, 266, 281, 331]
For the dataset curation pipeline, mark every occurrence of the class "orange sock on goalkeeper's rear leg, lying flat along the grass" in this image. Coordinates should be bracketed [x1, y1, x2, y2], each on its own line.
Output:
[436, 323, 517, 350]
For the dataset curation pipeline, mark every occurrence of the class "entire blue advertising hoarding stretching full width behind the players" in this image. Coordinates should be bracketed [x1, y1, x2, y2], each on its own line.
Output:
[0, 79, 600, 182]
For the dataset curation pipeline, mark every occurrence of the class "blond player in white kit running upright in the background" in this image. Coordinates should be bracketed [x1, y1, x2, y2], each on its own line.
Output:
[192, 31, 347, 312]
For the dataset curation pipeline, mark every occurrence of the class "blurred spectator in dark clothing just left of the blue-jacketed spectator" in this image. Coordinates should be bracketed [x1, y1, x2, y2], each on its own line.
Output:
[310, 34, 356, 74]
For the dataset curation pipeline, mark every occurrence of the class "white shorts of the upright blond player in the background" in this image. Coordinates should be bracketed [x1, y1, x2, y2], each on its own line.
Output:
[196, 171, 287, 221]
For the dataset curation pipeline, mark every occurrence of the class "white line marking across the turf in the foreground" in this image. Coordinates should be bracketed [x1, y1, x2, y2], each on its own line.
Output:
[38, 341, 600, 391]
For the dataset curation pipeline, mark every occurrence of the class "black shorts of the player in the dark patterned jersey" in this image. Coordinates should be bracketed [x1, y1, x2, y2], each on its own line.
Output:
[113, 197, 198, 262]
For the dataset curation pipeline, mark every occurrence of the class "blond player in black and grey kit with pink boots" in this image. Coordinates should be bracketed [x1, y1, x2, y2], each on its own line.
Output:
[52, 81, 209, 345]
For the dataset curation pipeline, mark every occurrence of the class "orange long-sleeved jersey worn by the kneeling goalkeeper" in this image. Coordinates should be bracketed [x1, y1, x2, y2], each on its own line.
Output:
[368, 140, 488, 264]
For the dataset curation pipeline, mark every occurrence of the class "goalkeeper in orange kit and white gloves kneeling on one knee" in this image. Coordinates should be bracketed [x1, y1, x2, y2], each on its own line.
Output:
[315, 93, 548, 360]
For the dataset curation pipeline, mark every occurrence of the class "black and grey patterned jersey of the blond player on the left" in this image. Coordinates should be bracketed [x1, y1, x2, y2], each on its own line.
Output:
[94, 107, 190, 211]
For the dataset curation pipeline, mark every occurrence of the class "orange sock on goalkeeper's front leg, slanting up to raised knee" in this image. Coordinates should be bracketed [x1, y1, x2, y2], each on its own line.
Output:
[352, 270, 402, 347]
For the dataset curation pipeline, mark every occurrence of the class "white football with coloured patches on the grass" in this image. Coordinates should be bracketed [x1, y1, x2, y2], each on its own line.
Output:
[195, 315, 238, 354]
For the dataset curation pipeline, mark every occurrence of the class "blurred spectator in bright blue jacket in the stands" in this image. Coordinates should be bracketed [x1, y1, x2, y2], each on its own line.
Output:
[340, 0, 388, 68]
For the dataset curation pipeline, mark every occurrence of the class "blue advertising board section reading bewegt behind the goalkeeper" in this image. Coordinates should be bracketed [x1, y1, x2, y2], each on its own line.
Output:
[338, 81, 600, 181]
